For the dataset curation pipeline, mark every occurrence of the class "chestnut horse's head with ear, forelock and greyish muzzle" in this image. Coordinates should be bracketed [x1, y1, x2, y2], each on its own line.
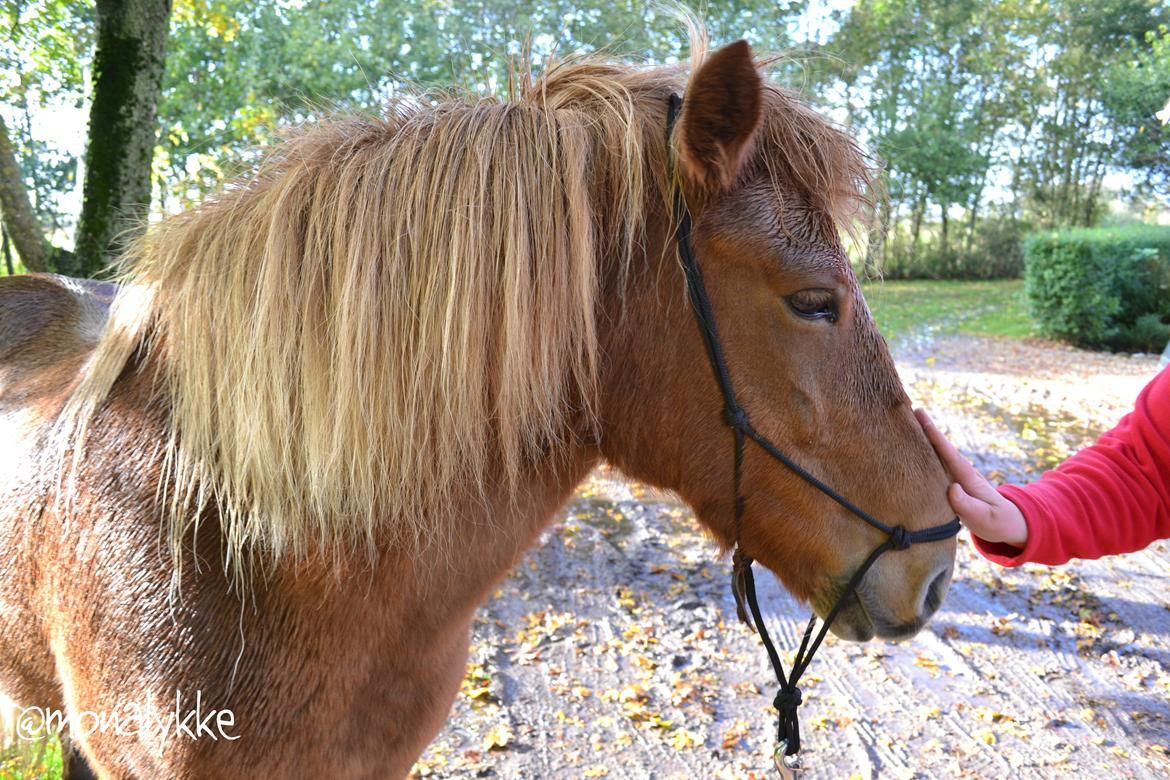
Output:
[601, 42, 955, 640]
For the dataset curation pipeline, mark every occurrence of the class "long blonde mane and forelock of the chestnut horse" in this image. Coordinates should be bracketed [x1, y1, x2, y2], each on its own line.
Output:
[63, 36, 867, 573]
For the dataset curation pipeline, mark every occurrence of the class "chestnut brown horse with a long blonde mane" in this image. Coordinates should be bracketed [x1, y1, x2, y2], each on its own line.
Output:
[0, 42, 955, 778]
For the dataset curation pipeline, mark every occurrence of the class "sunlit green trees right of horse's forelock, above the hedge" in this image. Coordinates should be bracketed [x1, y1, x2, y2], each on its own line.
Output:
[833, 0, 1170, 284]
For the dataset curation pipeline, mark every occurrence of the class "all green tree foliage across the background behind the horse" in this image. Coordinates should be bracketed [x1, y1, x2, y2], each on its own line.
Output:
[0, 0, 1170, 292]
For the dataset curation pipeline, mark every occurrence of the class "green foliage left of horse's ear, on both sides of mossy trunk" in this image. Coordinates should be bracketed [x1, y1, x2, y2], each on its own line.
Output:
[0, 0, 806, 229]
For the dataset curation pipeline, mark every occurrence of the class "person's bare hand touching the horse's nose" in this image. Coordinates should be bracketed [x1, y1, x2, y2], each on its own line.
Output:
[914, 409, 1027, 547]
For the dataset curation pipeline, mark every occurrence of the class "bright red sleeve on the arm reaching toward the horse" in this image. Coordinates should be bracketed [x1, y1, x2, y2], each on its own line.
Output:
[975, 368, 1170, 566]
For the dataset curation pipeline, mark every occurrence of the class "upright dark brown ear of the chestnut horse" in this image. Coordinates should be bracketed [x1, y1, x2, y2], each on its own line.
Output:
[679, 41, 764, 192]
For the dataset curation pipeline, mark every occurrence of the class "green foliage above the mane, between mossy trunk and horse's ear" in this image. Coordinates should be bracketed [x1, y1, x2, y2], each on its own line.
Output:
[154, 0, 805, 208]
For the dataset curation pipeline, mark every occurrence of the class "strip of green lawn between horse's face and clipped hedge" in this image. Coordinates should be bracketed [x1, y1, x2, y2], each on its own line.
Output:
[861, 279, 1037, 340]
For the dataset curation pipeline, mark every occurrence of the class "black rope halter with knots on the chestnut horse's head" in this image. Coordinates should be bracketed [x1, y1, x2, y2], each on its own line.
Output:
[666, 95, 962, 773]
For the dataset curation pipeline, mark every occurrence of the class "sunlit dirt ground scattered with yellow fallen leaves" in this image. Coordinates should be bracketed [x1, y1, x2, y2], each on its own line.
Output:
[415, 334, 1170, 780]
